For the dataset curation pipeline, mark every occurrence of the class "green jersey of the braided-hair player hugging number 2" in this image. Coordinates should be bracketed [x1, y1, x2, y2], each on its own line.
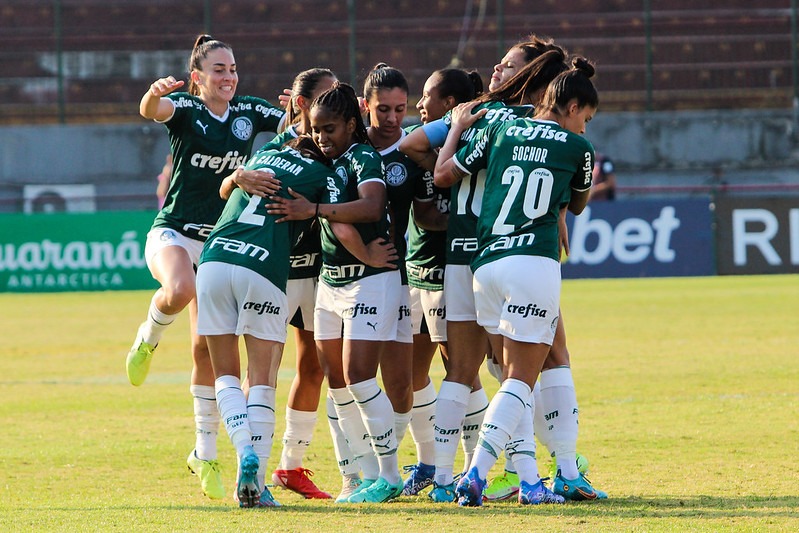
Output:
[320, 144, 392, 287]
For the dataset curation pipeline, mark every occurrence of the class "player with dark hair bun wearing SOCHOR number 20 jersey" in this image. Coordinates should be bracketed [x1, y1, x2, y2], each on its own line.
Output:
[435, 58, 599, 506]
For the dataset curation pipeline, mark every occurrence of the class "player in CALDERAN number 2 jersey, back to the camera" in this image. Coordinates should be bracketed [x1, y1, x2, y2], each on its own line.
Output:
[197, 137, 344, 507]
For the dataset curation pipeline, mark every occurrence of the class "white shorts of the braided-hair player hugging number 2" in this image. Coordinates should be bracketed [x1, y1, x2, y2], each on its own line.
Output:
[314, 271, 402, 341]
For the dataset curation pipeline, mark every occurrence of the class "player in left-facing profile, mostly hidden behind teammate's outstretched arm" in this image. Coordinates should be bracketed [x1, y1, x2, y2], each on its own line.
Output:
[403, 68, 487, 495]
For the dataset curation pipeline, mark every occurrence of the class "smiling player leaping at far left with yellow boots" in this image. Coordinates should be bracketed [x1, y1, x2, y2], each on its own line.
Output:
[125, 35, 284, 499]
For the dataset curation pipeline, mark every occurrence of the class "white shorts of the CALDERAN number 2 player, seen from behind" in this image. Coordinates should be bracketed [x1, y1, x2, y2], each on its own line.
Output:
[197, 261, 288, 343]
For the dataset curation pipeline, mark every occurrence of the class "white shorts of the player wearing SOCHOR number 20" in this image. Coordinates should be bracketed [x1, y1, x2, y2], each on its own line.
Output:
[474, 255, 561, 345]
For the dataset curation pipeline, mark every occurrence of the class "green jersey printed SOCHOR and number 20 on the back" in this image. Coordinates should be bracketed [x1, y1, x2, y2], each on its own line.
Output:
[453, 118, 594, 270]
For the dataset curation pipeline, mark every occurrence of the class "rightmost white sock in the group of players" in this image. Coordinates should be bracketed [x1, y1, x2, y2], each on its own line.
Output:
[541, 366, 580, 479]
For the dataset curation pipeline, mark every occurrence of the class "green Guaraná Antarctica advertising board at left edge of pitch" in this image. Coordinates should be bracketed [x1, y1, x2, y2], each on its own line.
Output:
[0, 211, 158, 292]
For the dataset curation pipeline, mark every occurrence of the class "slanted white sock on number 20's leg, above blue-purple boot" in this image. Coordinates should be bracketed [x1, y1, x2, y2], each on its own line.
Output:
[471, 378, 532, 479]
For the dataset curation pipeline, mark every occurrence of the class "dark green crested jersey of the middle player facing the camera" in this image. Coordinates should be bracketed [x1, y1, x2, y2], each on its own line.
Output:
[380, 131, 433, 285]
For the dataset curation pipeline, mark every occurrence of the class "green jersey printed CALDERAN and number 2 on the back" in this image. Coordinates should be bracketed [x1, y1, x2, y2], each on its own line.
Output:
[200, 147, 344, 292]
